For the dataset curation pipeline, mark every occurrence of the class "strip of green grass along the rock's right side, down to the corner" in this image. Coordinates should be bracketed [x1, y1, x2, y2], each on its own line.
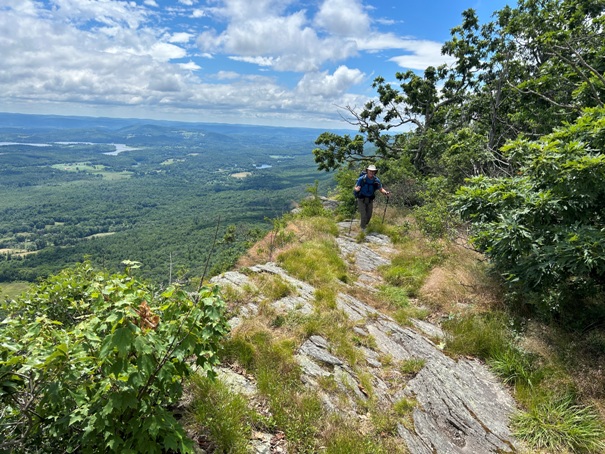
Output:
[444, 312, 605, 453]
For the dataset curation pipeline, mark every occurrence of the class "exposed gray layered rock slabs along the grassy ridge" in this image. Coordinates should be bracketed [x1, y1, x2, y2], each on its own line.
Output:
[208, 222, 521, 454]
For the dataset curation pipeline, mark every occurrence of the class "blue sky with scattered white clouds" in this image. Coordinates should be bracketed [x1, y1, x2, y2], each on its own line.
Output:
[0, 0, 515, 129]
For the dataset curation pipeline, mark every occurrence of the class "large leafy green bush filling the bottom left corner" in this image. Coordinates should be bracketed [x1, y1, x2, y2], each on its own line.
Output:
[0, 262, 228, 453]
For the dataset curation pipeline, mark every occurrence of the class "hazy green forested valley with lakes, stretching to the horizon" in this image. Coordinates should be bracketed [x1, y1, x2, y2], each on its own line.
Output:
[0, 113, 331, 282]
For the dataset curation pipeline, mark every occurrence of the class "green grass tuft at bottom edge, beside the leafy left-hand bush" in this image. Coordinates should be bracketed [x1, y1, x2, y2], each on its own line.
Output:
[191, 375, 254, 454]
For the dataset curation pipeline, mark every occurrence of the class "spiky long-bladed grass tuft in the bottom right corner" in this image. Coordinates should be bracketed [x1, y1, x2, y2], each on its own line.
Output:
[512, 396, 605, 453]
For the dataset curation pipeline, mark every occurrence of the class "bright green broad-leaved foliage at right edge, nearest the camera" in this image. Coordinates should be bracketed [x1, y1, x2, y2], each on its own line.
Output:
[456, 109, 605, 312]
